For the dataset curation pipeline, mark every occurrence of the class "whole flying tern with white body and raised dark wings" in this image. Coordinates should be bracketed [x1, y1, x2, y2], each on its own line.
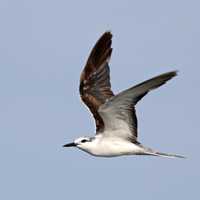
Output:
[63, 31, 184, 158]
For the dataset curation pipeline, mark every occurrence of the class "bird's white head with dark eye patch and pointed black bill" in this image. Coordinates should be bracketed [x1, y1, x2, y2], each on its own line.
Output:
[63, 137, 93, 149]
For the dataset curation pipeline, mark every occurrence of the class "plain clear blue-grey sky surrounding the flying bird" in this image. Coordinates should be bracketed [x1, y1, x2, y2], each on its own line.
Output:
[0, 0, 200, 200]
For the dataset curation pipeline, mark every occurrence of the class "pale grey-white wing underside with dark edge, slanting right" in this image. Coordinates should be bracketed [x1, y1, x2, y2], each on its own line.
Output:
[99, 71, 176, 142]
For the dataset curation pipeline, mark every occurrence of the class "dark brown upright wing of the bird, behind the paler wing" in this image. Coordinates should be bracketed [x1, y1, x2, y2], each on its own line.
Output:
[79, 32, 114, 132]
